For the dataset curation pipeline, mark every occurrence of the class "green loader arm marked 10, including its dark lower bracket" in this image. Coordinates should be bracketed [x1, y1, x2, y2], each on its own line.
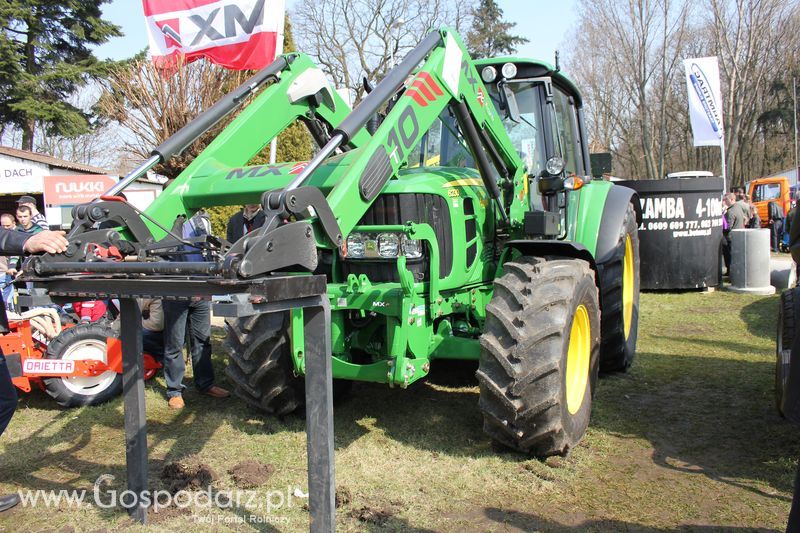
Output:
[202, 28, 524, 278]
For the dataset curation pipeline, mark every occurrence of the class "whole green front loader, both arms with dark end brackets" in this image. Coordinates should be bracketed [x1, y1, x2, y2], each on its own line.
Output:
[31, 28, 524, 278]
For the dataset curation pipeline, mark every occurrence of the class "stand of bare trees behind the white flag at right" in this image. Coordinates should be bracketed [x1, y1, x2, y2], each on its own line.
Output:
[567, 0, 800, 185]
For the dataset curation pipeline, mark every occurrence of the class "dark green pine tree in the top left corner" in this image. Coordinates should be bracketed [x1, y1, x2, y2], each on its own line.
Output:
[0, 0, 122, 150]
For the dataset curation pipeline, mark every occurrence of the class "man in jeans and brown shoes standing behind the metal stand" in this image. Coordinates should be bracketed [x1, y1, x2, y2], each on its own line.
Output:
[162, 211, 231, 409]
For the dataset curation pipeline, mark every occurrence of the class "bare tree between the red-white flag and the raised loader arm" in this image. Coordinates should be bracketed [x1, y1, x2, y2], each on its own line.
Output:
[291, 0, 474, 102]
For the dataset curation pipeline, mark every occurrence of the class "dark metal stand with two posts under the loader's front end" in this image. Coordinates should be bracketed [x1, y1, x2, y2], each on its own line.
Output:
[20, 275, 336, 532]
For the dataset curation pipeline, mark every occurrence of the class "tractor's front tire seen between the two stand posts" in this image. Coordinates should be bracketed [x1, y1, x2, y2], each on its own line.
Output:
[225, 312, 304, 416]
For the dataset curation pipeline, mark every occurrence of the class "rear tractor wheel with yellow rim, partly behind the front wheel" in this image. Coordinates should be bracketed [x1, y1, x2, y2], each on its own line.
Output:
[597, 204, 639, 372]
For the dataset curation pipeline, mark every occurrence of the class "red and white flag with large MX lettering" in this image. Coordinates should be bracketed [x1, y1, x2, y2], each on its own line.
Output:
[143, 0, 284, 70]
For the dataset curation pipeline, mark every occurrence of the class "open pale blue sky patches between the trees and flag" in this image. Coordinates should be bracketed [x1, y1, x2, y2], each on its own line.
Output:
[96, 0, 576, 63]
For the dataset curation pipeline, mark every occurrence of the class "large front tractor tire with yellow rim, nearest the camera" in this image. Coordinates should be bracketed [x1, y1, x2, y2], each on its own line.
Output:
[476, 257, 600, 456]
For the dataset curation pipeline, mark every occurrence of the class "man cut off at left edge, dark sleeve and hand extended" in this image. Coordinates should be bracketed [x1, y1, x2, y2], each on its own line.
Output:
[0, 228, 67, 512]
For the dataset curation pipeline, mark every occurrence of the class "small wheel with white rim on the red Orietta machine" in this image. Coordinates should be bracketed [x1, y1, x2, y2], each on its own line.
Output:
[43, 322, 122, 407]
